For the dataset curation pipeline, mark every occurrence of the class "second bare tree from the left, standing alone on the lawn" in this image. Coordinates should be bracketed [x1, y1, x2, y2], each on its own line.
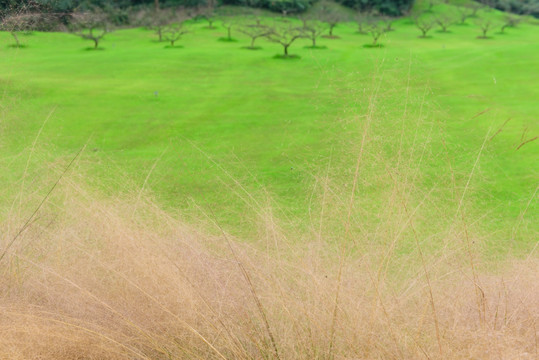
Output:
[69, 9, 112, 49]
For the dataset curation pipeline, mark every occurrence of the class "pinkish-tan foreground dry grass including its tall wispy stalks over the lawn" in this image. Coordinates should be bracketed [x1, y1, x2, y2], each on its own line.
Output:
[0, 75, 539, 360]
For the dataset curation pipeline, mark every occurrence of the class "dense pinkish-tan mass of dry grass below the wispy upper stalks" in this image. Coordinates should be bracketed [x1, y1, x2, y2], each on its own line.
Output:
[0, 170, 539, 359]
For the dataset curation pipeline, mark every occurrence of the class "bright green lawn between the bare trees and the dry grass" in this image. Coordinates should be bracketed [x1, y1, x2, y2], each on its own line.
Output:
[0, 8, 539, 251]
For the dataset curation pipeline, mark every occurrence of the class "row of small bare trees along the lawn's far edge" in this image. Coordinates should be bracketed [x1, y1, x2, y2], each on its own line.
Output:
[0, 6, 520, 52]
